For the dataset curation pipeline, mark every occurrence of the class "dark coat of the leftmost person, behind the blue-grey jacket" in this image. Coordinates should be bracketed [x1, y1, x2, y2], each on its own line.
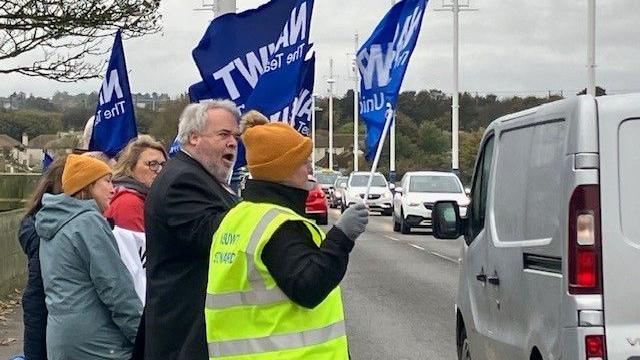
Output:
[18, 215, 47, 360]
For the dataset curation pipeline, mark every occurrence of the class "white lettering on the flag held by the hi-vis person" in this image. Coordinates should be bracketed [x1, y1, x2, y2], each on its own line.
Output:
[357, 6, 423, 90]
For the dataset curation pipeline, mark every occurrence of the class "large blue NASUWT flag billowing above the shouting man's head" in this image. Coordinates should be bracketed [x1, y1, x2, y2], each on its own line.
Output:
[194, 0, 314, 114]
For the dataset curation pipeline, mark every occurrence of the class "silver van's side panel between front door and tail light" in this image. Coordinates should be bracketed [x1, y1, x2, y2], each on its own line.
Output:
[487, 106, 571, 360]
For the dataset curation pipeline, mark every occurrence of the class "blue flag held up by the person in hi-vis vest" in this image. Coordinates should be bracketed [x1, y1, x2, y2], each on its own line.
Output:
[357, 0, 427, 160]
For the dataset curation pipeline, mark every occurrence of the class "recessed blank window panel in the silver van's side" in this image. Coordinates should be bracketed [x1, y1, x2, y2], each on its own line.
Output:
[493, 120, 566, 242]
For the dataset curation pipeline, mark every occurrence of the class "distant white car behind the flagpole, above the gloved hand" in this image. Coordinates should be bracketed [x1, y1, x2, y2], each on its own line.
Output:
[341, 172, 393, 216]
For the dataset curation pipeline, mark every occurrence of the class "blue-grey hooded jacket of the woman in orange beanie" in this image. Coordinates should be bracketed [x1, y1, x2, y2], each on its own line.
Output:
[36, 194, 142, 360]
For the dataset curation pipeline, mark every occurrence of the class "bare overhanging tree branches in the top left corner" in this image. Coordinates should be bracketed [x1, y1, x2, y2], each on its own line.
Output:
[0, 0, 160, 82]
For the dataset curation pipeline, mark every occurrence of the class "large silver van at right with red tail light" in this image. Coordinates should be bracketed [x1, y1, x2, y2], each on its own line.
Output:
[432, 94, 640, 360]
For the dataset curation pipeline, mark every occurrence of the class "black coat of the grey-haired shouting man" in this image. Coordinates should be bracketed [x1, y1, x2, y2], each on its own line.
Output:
[140, 151, 237, 360]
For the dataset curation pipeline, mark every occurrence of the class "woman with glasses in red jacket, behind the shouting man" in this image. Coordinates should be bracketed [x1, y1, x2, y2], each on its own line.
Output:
[104, 135, 167, 304]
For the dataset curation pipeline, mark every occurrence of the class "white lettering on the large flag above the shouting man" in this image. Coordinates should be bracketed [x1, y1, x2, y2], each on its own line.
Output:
[213, 2, 307, 100]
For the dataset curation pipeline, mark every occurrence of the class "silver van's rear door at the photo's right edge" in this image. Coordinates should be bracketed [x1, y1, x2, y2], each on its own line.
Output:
[598, 94, 640, 359]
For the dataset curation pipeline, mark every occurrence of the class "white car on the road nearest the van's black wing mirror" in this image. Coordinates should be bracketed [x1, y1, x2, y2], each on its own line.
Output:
[393, 171, 469, 234]
